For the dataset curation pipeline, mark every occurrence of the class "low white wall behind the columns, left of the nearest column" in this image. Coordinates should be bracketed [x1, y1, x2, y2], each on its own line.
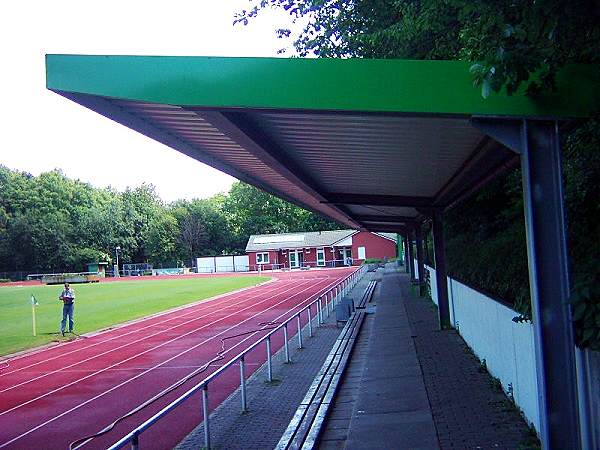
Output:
[426, 266, 539, 430]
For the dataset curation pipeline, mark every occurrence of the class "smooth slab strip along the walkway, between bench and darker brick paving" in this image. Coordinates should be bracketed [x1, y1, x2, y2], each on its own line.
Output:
[346, 270, 439, 450]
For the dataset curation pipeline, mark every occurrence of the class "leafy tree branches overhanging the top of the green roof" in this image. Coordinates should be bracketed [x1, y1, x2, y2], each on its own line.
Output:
[234, 0, 600, 96]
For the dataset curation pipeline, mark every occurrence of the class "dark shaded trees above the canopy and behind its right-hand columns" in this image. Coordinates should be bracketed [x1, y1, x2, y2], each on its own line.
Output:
[235, 0, 600, 350]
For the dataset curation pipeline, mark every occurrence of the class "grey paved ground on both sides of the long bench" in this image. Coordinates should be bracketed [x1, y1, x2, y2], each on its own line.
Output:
[177, 265, 536, 450]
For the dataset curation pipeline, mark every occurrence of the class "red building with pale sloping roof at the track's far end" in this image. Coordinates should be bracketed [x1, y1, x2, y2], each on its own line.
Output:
[246, 230, 396, 270]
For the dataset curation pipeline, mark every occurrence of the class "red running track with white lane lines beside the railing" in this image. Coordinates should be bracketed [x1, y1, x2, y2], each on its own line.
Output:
[0, 269, 353, 450]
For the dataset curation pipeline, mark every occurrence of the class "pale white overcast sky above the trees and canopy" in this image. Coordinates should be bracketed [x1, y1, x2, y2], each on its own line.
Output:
[0, 0, 298, 201]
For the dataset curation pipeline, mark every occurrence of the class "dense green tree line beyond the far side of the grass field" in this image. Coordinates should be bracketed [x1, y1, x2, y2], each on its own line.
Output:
[0, 166, 339, 273]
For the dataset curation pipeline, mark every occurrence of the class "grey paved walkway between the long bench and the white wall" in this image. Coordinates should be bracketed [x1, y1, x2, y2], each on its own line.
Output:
[319, 269, 536, 450]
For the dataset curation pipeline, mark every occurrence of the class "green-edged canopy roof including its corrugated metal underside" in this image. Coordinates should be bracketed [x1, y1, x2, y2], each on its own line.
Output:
[46, 55, 600, 231]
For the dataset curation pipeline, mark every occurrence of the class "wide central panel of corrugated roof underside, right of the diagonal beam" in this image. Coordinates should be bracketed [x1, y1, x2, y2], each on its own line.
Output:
[252, 112, 483, 196]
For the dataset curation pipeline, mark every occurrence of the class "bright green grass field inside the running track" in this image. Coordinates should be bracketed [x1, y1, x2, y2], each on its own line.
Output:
[0, 277, 269, 355]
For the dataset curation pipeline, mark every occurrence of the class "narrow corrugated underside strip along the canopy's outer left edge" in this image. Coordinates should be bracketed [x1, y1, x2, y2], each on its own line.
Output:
[111, 99, 346, 222]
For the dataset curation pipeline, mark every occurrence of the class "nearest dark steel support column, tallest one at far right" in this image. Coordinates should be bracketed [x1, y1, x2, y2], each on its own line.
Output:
[521, 120, 581, 449]
